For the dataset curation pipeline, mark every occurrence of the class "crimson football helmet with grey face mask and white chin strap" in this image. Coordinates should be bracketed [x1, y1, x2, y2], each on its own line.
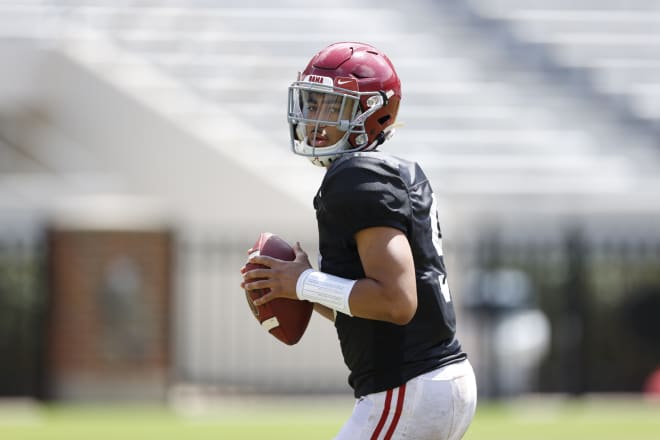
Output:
[288, 42, 401, 166]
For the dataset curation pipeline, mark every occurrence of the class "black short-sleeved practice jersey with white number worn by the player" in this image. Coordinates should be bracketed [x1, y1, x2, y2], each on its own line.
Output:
[314, 152, 466, 397]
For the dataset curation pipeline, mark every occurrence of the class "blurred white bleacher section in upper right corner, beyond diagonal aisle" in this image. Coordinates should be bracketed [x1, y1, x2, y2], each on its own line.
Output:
[470, 0, 660, 126]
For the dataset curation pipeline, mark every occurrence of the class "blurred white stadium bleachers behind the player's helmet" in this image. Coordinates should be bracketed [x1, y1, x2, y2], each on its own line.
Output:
[2, 1, 660, 222]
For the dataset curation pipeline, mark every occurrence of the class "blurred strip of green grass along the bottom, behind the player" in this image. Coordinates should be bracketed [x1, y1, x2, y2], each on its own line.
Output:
[0, 398, 660, 440]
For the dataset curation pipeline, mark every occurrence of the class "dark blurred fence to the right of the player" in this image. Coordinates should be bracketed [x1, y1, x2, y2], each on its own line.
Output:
[468, 229, 660, 397]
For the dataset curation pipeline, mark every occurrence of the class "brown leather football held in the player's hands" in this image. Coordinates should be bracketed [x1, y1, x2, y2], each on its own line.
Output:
[245, 232, 314, 345]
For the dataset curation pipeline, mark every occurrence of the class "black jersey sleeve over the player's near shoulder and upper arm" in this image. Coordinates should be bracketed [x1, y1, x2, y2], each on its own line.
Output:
[323, 158, 411, 235]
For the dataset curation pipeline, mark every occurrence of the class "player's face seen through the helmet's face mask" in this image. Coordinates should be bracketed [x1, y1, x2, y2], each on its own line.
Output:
[303, 92, 356, 148]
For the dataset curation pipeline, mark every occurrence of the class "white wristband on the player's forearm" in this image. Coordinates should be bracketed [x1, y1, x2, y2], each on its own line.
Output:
[296, 269, 356, 316]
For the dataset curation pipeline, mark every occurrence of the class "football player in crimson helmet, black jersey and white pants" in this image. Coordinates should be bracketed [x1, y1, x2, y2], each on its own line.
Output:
[242, 42, 477, 440]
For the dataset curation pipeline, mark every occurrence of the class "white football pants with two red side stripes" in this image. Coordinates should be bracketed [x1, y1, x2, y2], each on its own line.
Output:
[335, 360, 477, 440]
